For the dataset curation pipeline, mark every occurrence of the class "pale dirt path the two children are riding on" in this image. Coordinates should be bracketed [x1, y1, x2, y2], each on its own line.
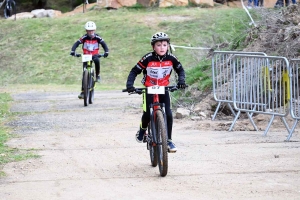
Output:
[0, 90, 300, 200]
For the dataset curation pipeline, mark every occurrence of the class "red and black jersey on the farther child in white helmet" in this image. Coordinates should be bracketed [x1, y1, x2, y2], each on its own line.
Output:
[72, 34, 109, 55]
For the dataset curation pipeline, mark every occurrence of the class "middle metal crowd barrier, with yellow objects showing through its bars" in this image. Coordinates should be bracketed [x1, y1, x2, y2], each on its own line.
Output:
[231, 55, 291, 139]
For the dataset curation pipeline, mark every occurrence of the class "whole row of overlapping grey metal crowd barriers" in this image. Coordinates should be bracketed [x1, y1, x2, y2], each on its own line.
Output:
[212, 51, 300, 141]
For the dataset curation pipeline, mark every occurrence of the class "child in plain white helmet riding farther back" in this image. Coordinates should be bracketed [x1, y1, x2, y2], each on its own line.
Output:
[70, 21, 109, 99]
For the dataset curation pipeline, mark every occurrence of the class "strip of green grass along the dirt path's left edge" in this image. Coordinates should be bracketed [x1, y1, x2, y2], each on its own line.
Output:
[0, 93, 38, 177]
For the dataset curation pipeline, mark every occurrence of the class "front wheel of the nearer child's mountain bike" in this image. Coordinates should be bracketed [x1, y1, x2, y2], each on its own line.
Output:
[155, 110, 168, 176]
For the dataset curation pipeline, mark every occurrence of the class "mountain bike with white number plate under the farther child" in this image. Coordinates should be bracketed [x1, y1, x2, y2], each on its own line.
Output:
[75, 54, 103, 106]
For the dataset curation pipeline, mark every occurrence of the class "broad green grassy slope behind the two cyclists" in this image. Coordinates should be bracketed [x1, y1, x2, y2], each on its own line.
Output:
[0, 7, 253, 89]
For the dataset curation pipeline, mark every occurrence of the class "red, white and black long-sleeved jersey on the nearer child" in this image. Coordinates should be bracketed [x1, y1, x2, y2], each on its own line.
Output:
[126, 52, 185, 88]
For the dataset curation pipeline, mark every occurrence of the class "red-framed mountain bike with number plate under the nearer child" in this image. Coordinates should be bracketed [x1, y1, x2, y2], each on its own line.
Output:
[122, 86, 178, 177]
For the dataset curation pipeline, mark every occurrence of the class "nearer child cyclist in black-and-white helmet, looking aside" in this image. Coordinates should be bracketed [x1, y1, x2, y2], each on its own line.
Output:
[126, 32, 186, 153]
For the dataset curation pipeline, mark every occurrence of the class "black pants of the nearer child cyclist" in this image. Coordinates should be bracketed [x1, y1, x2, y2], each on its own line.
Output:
[142, 92, 173, 139]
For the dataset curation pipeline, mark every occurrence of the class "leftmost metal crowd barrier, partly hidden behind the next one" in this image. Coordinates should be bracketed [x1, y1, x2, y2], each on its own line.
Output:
[212, 51, 266, 120]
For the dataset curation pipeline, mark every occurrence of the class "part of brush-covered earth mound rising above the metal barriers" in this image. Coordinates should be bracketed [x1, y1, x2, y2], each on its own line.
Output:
[244, 4, 300, 59]
